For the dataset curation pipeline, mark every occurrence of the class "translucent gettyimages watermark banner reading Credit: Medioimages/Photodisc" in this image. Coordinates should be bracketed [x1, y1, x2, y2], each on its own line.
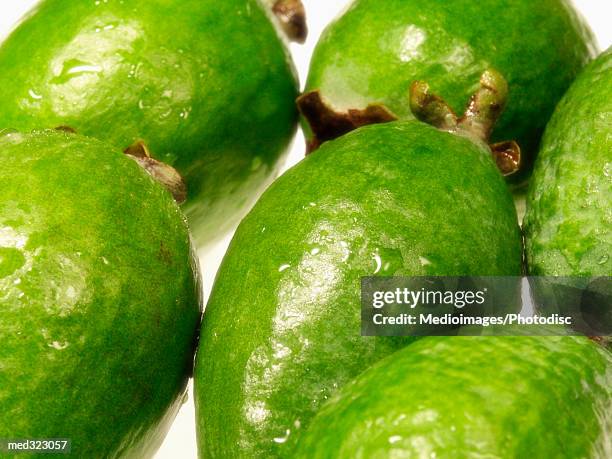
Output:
[361, 276, 612, 337]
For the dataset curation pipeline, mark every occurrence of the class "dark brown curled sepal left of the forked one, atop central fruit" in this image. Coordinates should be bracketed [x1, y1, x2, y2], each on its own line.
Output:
[297, 91, 398, 154]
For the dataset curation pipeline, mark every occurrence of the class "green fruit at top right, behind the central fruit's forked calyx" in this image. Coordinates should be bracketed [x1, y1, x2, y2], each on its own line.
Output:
[306, 0, 596, 183]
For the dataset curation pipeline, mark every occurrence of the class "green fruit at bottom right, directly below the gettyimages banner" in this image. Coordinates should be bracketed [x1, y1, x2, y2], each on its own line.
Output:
[294, 336, 612, 459]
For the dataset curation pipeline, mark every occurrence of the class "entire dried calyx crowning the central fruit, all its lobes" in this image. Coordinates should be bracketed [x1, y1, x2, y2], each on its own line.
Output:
[297, 70, 521, 175]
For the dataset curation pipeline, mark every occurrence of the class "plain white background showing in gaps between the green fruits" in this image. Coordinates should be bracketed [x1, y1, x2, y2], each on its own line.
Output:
[0, 0, 612, 459]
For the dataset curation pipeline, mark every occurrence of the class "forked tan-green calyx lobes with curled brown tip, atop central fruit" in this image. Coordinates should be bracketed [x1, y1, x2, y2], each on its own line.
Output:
[410, 69, 521, 175]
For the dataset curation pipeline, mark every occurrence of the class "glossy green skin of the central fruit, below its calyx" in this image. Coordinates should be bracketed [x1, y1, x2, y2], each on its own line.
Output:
[195, 121, 521, 458]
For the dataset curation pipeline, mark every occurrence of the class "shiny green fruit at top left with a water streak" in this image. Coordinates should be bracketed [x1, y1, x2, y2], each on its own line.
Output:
[0, 0, 297, 246]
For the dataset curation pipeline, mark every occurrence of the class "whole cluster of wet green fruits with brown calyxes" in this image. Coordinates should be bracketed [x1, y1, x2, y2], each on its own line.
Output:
[0, 0, 612, 458]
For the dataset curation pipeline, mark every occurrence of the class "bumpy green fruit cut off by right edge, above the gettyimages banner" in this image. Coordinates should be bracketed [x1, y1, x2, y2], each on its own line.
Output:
[524, 49, 612, 276]
